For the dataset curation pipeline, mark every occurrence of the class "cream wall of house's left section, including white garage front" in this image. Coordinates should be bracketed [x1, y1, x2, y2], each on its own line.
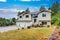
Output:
[16, 14, 32, 27]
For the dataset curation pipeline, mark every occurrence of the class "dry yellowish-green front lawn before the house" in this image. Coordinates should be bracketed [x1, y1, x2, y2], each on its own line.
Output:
[0, 28, 53, 40]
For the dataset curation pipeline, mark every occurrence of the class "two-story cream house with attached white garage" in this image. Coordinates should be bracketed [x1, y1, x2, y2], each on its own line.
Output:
[16, 10, 51, 27]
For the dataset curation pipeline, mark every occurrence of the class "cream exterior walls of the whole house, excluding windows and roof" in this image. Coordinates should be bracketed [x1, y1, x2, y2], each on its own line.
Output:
[16, 12, 51, 27]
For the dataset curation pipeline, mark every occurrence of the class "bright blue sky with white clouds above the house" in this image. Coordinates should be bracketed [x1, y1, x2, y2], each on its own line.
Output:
[0, 0, 60, 19]
